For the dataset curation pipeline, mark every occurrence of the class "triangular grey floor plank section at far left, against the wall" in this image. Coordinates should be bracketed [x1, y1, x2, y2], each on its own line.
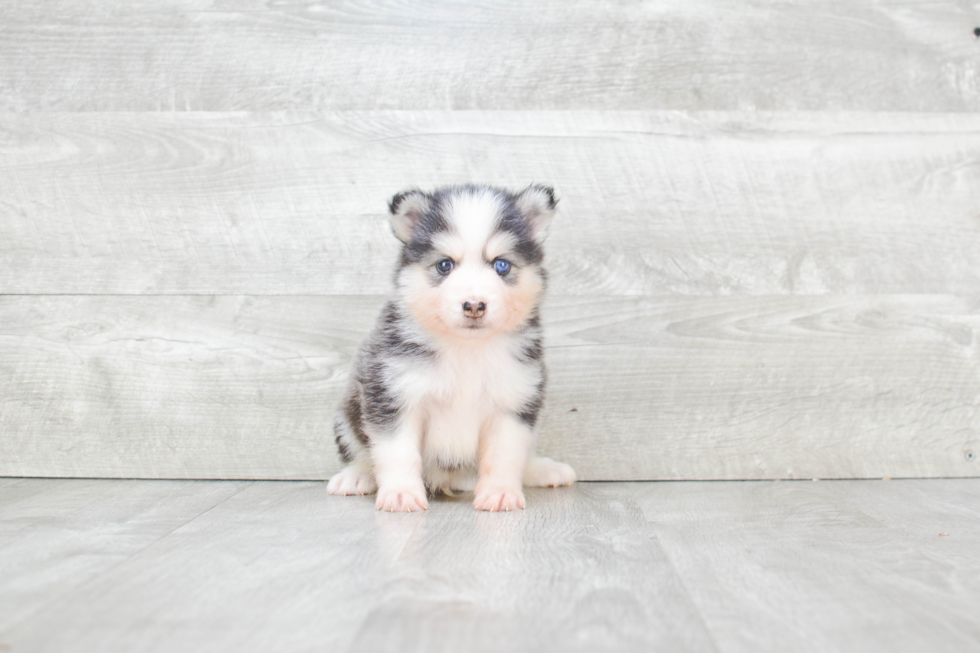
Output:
[0, 479, 248, 636]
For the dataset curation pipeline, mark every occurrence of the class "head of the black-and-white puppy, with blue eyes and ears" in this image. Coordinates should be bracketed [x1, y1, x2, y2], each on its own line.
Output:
[389, 186, 556, 338]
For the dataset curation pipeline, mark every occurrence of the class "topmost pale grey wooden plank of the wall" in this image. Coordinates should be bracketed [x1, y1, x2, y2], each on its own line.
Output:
[0, 0, 980, 111]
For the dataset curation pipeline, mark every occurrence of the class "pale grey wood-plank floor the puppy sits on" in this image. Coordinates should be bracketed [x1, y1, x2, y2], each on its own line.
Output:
[0, 478, 980, 652]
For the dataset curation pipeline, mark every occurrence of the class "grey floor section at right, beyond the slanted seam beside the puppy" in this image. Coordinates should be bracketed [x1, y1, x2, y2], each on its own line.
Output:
[632, 480, 980, 653]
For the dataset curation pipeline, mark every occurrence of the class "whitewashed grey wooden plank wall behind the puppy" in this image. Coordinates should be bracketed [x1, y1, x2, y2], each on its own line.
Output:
[0, 0, 980, 479]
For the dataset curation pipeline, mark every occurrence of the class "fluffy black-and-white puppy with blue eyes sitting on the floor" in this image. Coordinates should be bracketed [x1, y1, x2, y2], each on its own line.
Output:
[327, 186, 575, 512]
